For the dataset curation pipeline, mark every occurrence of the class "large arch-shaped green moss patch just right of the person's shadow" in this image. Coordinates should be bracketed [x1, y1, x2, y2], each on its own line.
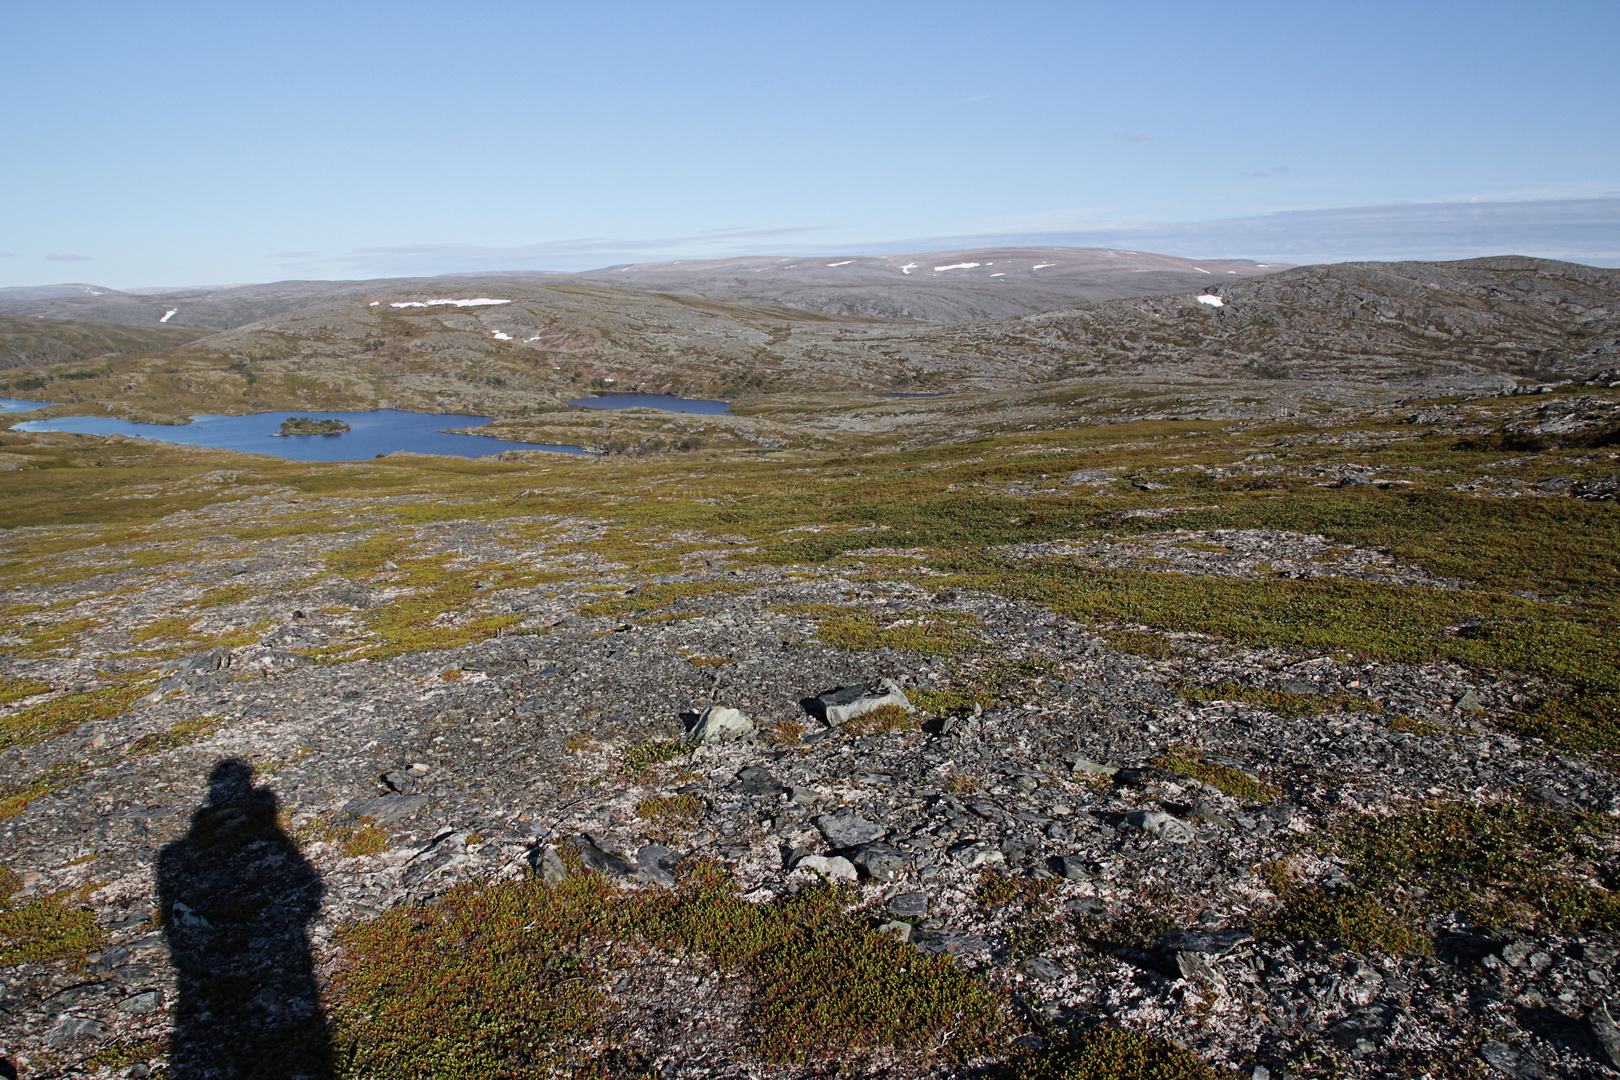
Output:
[335, 871, 1008, 1080]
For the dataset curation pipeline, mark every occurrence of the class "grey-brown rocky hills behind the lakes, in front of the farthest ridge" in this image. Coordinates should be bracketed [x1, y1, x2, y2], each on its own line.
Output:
[0, 259, 1620, 447]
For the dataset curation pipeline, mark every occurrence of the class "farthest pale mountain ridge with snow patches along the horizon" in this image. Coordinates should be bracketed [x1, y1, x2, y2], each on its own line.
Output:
[0, 248, 1286, 330]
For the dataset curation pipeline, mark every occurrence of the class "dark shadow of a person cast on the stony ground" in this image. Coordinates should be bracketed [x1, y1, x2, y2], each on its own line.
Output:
[157, 758, 334, 1080]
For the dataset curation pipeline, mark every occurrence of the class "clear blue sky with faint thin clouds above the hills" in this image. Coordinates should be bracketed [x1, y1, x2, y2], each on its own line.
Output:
[0, 0, 1620, 287]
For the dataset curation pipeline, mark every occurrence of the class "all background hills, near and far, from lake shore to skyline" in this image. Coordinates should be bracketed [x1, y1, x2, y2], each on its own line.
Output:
[0, 248, 1620, 449]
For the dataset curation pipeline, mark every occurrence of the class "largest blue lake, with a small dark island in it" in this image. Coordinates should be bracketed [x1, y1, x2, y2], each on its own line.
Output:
[16, 408, 585, 461]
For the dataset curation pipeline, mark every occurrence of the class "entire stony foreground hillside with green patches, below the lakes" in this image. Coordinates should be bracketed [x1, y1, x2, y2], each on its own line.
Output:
[0, 371, 1620, 1077]
